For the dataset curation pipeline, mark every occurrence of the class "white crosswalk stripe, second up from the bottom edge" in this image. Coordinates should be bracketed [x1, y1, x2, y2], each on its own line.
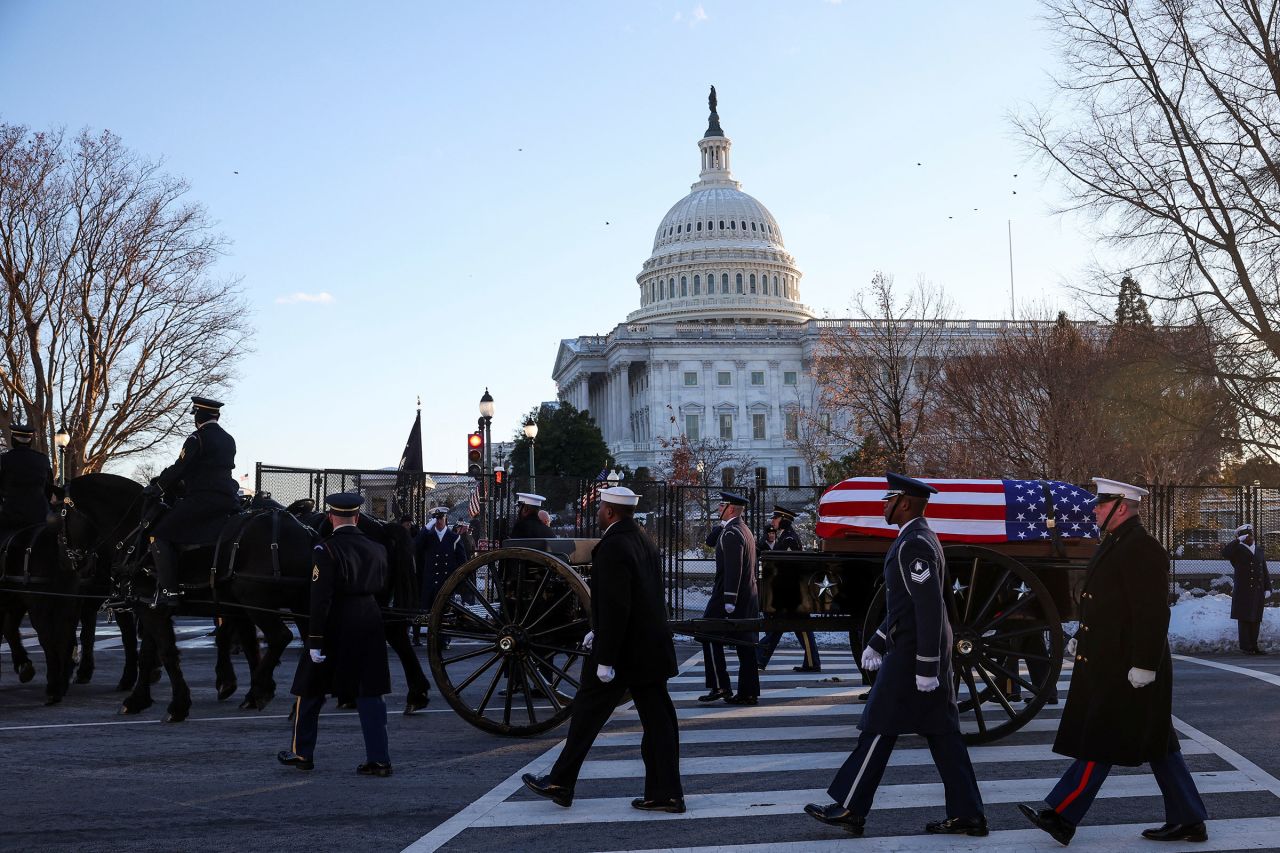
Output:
[472, 762, 1263, 827]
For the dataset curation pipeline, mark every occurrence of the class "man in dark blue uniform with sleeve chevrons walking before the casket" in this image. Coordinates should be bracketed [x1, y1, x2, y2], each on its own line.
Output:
[804, 473, 987, 836]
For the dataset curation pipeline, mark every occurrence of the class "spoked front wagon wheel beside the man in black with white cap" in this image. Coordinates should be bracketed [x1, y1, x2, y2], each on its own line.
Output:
[428, 548, 590, 735]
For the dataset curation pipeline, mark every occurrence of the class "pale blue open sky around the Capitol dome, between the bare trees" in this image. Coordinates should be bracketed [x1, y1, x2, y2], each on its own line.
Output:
[0, 0, 1093, 473]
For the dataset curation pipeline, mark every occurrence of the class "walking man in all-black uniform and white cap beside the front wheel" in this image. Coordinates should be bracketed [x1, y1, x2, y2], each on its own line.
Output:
[522, 485, 685, 813]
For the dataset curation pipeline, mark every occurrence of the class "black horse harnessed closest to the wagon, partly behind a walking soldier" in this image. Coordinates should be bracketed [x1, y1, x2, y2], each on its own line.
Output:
[120, 494, 426, 722]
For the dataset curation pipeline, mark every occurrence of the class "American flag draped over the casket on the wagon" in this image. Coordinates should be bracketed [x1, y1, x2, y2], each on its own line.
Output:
[817, 476, 1098, 542]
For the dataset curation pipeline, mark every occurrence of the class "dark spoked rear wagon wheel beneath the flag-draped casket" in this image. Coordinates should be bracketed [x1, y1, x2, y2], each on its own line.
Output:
[943, 546, 1062, 745]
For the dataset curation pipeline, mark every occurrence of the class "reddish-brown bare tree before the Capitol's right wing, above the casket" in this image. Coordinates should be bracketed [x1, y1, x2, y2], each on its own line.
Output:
[814, 273, 950, 470]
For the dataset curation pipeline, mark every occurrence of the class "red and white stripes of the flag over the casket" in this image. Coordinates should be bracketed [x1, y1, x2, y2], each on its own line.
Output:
[817, 476, 1007, 542]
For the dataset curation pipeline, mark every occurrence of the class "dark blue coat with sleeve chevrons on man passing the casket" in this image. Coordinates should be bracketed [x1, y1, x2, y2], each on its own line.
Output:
[860, 517, 960, 735]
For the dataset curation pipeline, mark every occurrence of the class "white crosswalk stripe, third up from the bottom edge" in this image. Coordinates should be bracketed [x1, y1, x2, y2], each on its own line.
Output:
[560, 739, 1208, 778]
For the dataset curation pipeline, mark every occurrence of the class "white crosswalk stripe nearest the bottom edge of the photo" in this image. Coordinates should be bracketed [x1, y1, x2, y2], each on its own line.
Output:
[604, 809, 1280, 853]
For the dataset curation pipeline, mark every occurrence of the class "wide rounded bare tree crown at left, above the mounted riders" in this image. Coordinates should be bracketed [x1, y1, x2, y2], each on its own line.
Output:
[0, 124, 250, 476]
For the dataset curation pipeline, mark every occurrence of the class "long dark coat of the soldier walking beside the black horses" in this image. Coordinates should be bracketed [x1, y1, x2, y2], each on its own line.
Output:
[291, 525, 392, 698]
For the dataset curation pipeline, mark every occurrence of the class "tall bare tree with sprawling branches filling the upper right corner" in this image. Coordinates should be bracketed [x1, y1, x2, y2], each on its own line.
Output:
[1016, 0, 1280, 453]
